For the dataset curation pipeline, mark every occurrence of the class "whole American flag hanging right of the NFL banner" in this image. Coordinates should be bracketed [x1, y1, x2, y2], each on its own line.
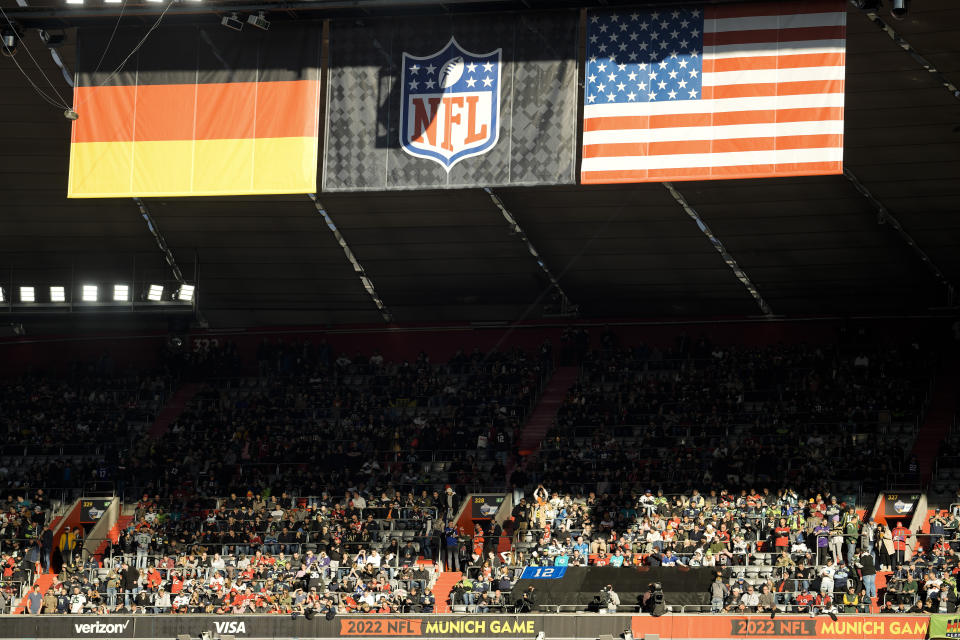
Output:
[581, 0, 846, 184]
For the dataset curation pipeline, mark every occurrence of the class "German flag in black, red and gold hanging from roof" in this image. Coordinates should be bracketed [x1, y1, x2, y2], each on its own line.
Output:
[67, 25, 322, 198]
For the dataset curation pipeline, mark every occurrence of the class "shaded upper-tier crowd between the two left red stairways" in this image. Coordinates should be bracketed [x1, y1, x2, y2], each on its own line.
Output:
[128, 342, 552, 496]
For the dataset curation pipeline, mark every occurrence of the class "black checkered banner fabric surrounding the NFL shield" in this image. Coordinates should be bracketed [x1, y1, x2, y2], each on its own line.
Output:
[323, 11, 578, 191]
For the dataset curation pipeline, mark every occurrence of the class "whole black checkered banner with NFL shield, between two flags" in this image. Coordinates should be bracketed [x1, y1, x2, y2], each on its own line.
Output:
[323, 12, 577, 191]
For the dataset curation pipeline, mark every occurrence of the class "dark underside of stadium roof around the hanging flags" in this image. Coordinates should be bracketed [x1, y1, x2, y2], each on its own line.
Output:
[0, 0, 960, 326]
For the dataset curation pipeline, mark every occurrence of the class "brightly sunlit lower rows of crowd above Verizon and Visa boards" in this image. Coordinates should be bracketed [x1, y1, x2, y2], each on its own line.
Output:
[31, 550, 435, 615]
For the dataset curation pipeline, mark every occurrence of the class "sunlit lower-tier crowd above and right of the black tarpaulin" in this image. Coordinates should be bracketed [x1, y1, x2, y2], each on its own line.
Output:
[509, 485, 960, 613]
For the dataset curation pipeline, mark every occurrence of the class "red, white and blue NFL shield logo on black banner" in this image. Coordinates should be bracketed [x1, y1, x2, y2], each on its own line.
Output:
[400, 38, 501, 173]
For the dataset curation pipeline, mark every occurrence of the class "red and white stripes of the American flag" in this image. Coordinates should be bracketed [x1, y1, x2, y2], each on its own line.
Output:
[581, 0, 846, 184]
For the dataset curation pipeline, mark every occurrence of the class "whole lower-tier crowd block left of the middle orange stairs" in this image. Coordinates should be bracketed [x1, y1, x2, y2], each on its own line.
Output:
[25, 489, 458, 614]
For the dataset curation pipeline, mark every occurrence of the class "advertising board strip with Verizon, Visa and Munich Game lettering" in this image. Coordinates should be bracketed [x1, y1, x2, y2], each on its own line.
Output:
[0, 613, 931, 640]
